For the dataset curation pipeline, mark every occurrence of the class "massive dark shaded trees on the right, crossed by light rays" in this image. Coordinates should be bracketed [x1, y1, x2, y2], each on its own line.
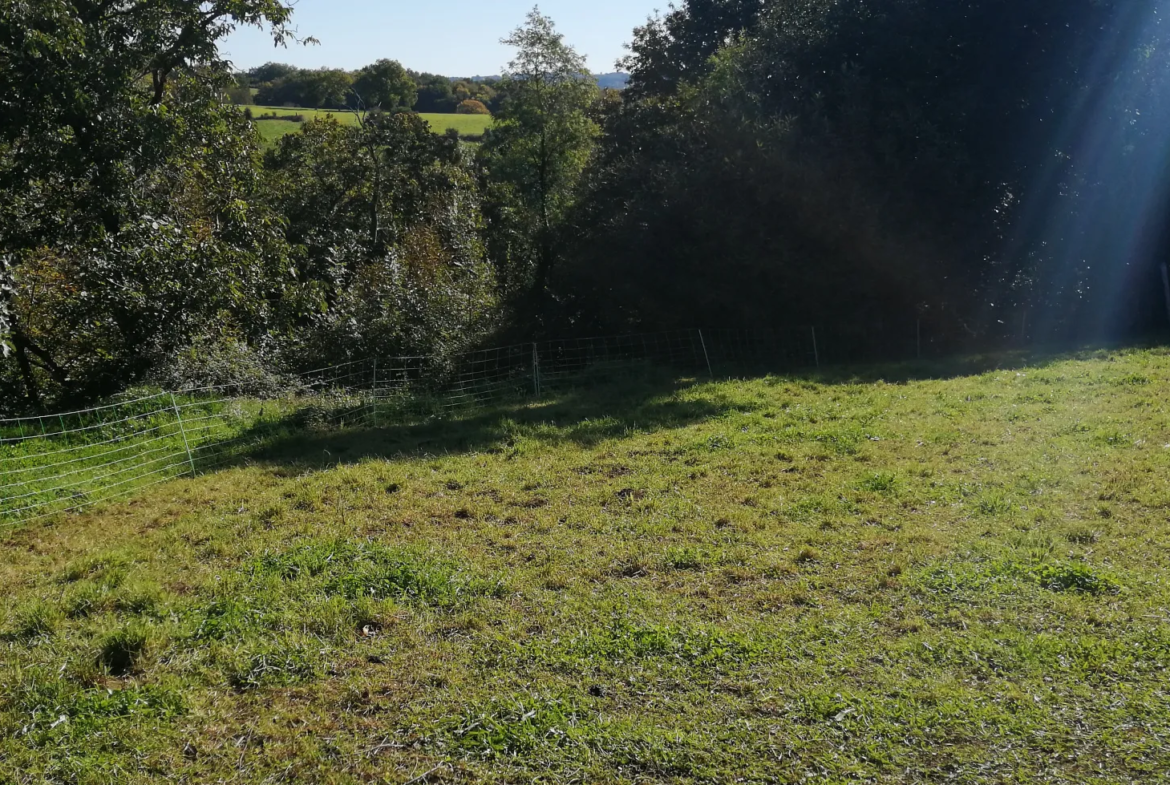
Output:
[557, 0, 1170, 342]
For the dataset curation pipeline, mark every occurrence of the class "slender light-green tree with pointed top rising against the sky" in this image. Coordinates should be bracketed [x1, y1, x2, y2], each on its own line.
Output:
[482, 9, 598, 320]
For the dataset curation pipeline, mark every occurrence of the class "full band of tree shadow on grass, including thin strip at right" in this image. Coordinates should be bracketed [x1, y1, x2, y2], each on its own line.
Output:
[200, 341, 1160, 471]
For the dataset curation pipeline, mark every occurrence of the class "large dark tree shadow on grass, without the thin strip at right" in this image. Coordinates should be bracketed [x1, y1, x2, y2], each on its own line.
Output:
[219, 372, 745, 471]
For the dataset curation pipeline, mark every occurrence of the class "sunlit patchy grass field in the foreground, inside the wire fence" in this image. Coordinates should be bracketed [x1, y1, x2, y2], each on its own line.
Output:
[0, 350, 1170, 783]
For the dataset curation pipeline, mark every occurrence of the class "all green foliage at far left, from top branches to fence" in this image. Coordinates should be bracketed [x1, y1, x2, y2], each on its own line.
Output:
[0, 0, 291, 407]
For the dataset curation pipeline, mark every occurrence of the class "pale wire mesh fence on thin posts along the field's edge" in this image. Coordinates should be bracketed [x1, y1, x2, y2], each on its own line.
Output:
[0, 330, 820, 526]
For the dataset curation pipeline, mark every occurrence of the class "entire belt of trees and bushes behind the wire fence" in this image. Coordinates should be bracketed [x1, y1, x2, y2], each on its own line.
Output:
[0, 0, 1170, 409]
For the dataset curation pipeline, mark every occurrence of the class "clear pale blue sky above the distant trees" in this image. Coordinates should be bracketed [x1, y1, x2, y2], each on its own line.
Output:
[220, 0, 667, 76]
